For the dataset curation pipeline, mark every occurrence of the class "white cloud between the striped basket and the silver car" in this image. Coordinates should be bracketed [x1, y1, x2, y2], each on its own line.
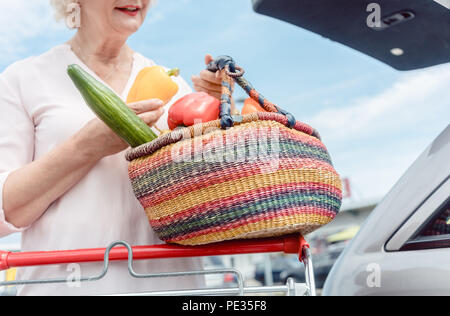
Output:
[306, 64, 450, 199]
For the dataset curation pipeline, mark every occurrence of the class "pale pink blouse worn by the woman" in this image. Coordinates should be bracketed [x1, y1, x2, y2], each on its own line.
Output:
[0, 44, 204, 295]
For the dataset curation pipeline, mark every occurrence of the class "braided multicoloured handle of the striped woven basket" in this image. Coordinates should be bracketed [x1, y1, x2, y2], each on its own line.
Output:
[207, 56, 296, 129]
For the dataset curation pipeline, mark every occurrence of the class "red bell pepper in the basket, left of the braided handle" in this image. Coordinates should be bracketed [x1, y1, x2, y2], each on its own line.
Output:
[167, 92, 220, 130]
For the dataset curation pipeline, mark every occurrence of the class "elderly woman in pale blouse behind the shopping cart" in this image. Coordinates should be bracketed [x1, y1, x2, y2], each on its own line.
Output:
[0, 0, 225, 295]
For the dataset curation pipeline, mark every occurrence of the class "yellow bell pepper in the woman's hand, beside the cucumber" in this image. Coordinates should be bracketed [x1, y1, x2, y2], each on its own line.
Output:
[127, 66, 180, 104]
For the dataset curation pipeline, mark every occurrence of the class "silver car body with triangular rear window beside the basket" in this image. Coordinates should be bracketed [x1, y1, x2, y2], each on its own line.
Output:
[323, 125, 450, 296]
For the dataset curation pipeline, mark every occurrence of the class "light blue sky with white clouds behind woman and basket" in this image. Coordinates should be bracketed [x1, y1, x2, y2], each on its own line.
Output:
[0, 0, 450, 244]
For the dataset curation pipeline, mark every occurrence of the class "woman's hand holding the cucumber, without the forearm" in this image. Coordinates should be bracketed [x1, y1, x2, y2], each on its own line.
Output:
[76, 99, 164, 160]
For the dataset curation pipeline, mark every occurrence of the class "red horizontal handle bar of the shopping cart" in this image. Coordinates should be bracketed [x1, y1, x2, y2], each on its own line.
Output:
[0, 235, 309, 271]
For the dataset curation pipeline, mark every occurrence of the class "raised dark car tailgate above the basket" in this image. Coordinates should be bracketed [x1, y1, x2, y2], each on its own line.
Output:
[252, 0, 450, 70]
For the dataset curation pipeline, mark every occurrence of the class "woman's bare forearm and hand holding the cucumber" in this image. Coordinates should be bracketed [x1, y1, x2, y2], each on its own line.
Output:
[0, 100, 164, 227]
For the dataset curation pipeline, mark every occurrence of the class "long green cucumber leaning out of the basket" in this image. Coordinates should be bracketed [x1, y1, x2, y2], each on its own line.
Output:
[67, 65, 157, 147]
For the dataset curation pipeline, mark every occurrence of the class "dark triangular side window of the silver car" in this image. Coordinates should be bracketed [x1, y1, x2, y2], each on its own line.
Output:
[403, 198, 450, 250]
